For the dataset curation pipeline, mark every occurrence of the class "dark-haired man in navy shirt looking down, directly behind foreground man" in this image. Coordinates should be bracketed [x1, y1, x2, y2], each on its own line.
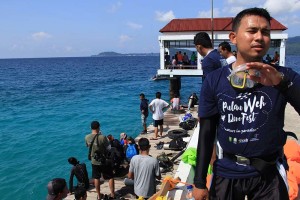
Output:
[194, 32, 224, 80]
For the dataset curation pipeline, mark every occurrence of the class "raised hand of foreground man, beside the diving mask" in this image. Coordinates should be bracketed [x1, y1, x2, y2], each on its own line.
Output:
[247, 62, 282, 86]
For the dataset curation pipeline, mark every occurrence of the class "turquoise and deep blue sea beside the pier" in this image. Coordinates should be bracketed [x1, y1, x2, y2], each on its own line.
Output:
[0, 57, 201, 200]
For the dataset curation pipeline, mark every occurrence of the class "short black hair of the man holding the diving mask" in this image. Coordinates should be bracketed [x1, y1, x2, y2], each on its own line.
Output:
[232, 7, 272, 32]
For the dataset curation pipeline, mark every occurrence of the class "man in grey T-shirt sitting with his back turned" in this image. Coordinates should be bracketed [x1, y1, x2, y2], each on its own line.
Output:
[124, 138, 161, 199]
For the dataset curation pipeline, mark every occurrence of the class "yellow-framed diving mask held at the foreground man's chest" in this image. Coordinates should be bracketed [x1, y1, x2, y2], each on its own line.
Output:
[227, 64, 260, 89]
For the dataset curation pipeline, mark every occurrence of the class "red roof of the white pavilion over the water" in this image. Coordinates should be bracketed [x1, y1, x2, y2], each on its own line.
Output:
[159, 17, 287, 33]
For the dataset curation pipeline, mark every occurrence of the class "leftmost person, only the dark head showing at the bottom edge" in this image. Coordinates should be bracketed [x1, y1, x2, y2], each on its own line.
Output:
[47, 178, 69, 200]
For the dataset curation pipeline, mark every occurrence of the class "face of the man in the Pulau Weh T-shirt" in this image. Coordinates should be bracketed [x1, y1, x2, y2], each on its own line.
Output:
[229, 15, 270, 62]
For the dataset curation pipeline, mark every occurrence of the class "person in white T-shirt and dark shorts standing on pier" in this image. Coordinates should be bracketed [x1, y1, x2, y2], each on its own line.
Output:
[149, 92, 169, 140]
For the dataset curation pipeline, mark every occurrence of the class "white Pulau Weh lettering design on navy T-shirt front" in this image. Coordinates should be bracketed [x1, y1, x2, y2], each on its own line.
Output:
[219, 91, 272, 137]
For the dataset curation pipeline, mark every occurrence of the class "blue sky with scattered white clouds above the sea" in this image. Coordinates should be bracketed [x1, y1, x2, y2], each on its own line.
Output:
[0, 0, 300, 58]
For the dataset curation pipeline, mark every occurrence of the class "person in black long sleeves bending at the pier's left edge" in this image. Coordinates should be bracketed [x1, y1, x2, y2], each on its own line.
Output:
[68, 157, 89, 193]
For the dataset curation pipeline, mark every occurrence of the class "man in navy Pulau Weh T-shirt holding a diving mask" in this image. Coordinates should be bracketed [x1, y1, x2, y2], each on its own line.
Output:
[193, 8, 300, 200]
